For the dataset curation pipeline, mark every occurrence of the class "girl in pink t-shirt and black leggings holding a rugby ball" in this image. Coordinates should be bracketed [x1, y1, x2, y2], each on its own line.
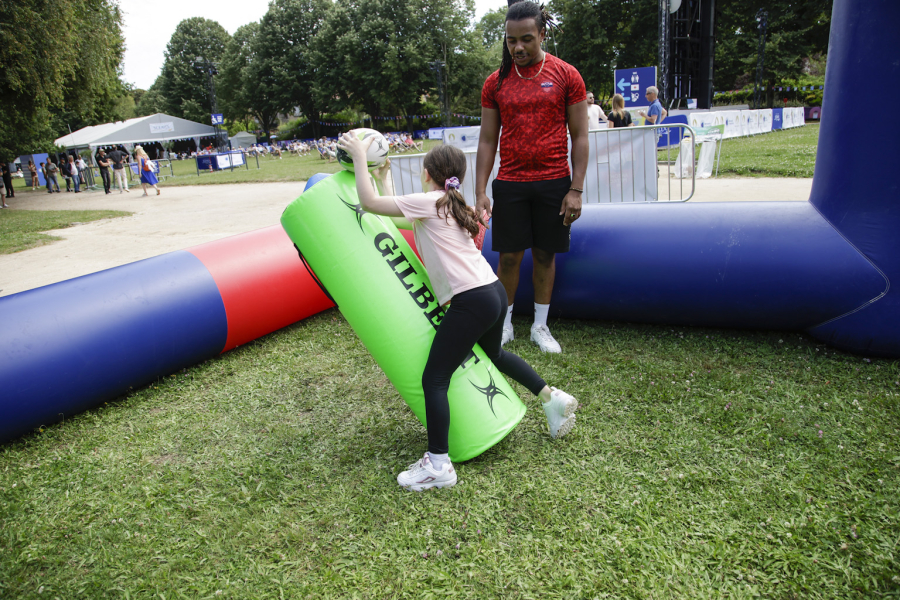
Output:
[338, 132, 578, 492]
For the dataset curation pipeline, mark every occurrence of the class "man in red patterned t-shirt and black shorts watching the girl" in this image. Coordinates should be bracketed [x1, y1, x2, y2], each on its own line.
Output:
[475, 0, 588, 352]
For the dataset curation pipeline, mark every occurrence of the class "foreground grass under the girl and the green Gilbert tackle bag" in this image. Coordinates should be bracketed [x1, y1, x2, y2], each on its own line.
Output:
[0, 310, 900, 599]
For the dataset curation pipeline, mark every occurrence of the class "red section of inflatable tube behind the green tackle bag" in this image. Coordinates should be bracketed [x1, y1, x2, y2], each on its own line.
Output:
[187, 225, 334, 352]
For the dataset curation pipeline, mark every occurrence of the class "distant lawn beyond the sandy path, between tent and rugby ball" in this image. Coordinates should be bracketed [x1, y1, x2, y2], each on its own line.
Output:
[163, 140, 440, 185]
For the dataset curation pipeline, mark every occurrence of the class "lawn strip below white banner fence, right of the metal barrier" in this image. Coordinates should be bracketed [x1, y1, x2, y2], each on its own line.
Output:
[659, 123, 819, 177]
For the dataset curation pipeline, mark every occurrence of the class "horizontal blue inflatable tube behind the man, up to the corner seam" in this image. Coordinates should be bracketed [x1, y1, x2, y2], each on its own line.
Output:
[485, 202, 887, 329]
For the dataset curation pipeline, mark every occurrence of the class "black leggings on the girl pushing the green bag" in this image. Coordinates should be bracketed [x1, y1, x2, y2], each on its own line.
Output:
[422, 281, 547, 454]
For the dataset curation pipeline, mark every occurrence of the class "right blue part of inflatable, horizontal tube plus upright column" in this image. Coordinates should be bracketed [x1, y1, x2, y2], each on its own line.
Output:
[485, 0, 900, 357]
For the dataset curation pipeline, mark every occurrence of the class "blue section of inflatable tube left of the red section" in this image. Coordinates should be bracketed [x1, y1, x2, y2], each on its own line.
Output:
[0, 251, 228, 440]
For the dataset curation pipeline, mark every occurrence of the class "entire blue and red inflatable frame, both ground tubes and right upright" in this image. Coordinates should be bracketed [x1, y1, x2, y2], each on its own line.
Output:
[0, 0, 900, 441]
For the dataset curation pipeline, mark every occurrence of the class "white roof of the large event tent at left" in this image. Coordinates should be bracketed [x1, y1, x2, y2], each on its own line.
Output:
[56, 113, 216, 150]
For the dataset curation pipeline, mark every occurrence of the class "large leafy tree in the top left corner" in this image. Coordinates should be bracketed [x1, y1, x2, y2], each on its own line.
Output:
[0, 0, 125, 159]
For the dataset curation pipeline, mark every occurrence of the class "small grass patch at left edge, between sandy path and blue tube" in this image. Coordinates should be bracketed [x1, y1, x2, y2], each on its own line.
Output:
[0, 210, 132, 254]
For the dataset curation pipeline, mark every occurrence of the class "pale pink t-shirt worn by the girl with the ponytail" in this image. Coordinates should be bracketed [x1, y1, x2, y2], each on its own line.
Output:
[394, 191, 497, 306]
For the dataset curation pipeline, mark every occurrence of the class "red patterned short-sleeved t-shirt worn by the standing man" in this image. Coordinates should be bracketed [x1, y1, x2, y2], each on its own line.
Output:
[481, 53, 587, 181]
